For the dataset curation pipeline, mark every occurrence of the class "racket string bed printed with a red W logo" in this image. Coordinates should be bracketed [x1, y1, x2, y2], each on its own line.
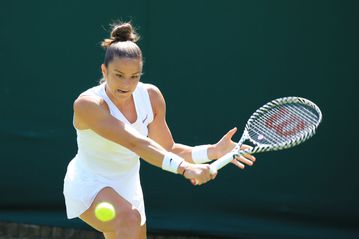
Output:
[248, 103, 319, 144]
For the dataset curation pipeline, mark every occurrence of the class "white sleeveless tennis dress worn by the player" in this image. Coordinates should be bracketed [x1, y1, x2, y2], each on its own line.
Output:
[63, 82, 153, 225]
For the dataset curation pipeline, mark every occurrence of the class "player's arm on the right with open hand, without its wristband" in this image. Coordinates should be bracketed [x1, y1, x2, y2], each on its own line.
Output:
[147, 84, 255, 168]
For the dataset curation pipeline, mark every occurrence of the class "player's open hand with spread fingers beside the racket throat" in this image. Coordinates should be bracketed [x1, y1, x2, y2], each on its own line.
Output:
[213, 127, 256, 169]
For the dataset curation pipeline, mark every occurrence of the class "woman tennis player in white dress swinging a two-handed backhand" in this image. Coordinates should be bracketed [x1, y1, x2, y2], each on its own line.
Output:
[64, 23, 255, 239]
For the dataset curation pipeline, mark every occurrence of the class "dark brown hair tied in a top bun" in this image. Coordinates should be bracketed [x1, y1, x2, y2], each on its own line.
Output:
[101, 22, 142, 67]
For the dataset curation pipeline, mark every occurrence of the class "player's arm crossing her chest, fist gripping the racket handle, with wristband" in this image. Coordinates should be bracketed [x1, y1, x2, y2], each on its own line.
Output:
[74, 96, 215, 184]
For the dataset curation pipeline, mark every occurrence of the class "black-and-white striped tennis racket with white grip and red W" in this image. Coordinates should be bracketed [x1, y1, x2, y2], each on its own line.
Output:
[210, 97, 322, 174]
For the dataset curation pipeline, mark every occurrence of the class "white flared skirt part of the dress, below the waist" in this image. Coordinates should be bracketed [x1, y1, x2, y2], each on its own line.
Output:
[63, 157, 146, 225]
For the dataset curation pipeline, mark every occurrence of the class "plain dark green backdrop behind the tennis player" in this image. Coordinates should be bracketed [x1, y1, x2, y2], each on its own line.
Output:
[0, 0, 359, 238]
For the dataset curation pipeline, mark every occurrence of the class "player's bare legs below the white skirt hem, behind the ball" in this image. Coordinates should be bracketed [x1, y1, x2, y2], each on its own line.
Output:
[80, 187, 141, 239]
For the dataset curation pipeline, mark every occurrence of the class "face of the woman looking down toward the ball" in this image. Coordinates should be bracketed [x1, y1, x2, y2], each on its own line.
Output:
[101, 58, 142, 100]
